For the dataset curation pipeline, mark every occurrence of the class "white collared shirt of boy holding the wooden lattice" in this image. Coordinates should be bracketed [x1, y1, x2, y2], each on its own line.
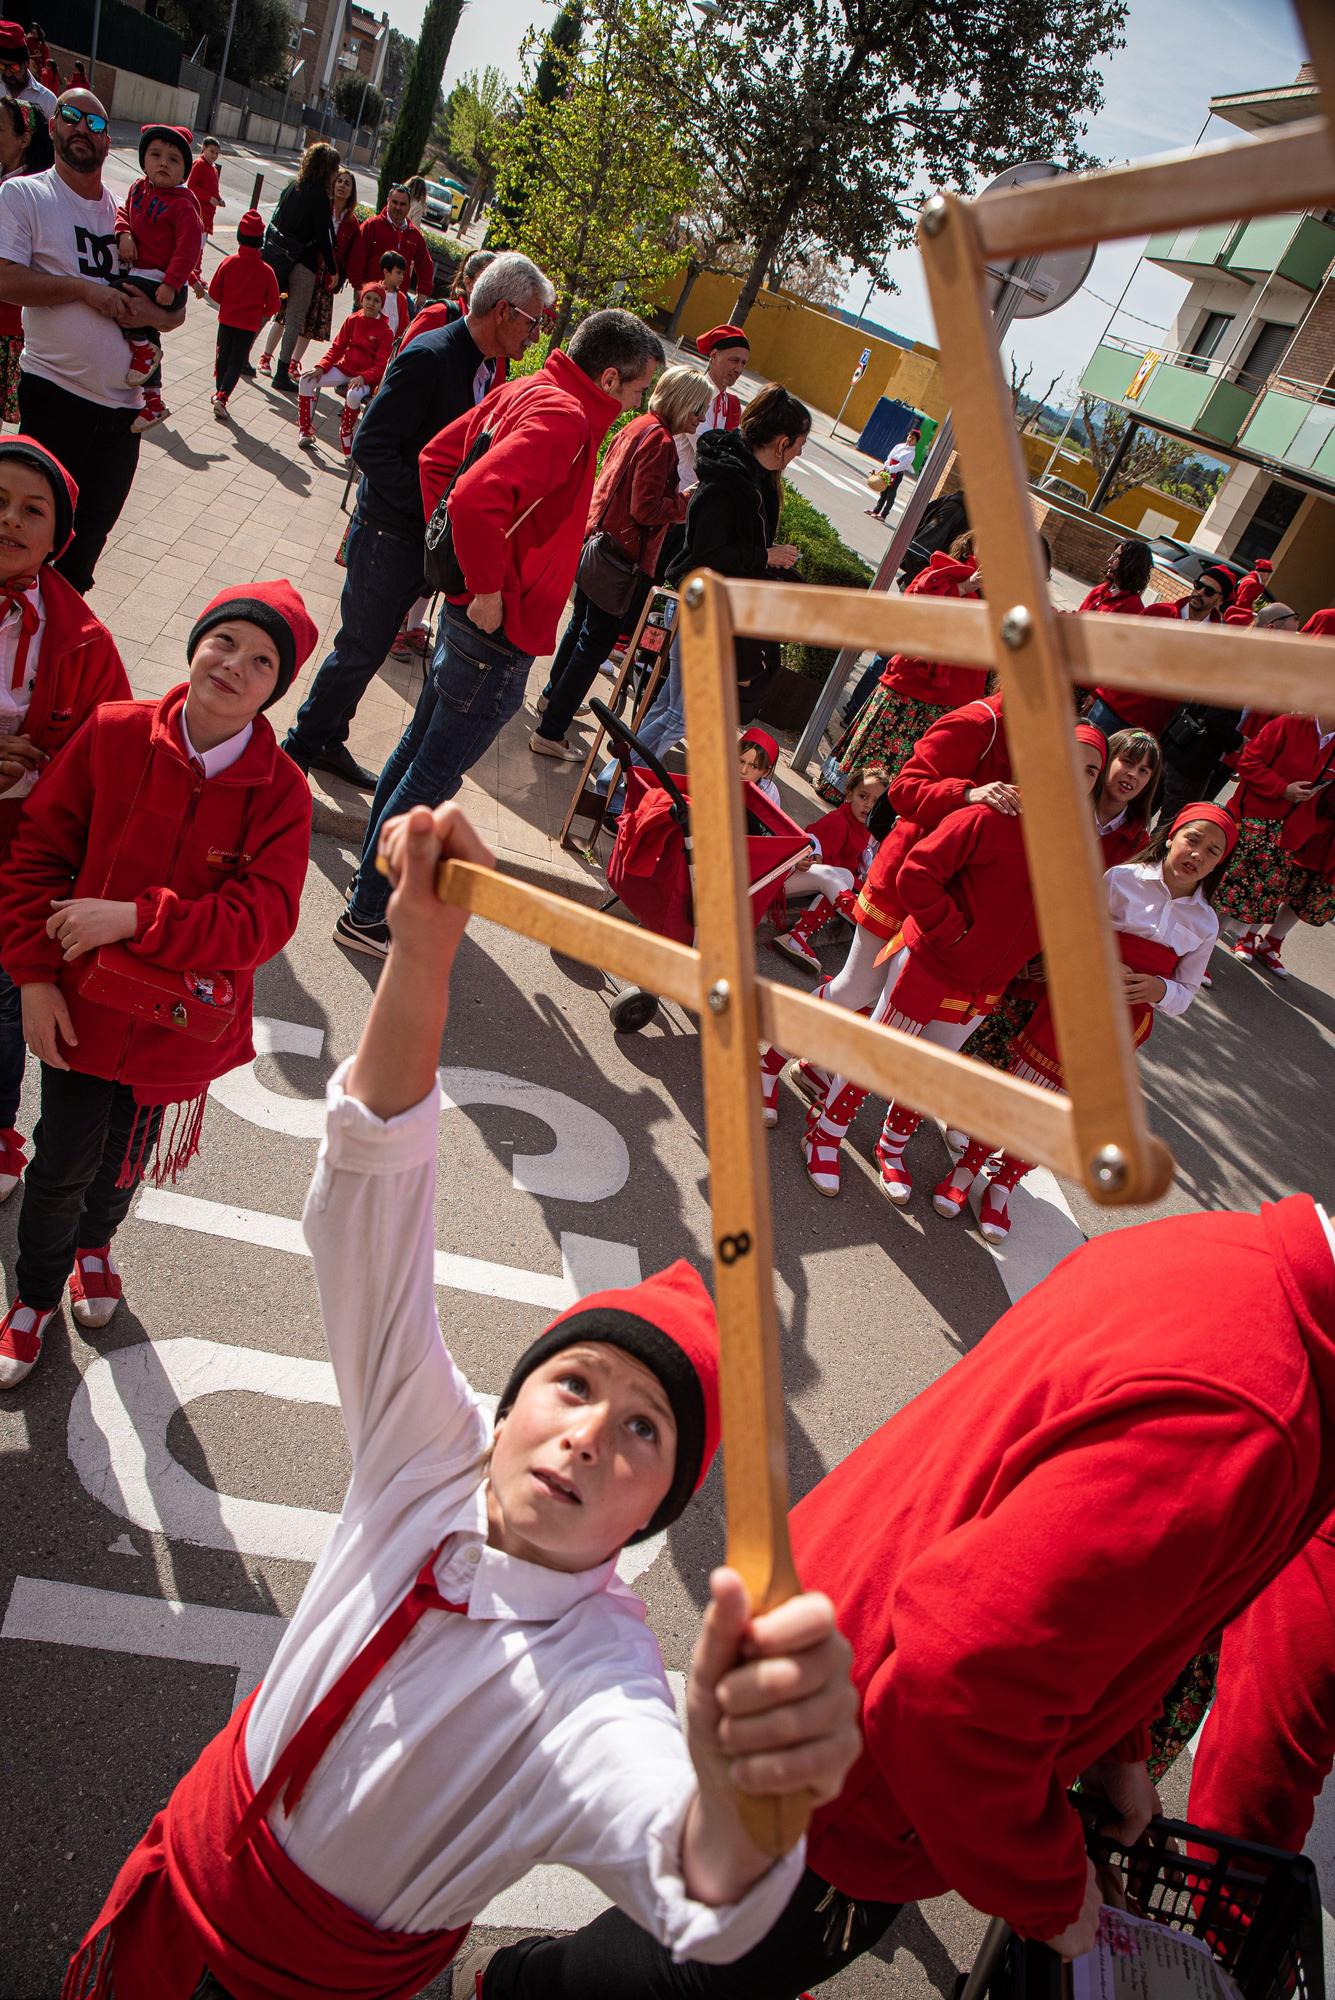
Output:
[246, 1064, 805, 1962]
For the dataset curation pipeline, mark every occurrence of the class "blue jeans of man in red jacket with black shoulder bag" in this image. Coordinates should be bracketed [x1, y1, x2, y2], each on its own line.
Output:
[350, 604, 534, 924]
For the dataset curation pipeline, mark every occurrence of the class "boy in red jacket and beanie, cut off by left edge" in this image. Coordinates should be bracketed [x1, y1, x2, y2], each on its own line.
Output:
[0, 436, 130, 1202]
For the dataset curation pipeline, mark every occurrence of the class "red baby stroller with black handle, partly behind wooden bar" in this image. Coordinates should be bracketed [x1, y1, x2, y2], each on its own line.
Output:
[590, 700, 811, 1034]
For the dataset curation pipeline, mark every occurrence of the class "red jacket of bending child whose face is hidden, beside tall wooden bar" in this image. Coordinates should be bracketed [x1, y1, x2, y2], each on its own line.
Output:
[895, 806, 1039, 996]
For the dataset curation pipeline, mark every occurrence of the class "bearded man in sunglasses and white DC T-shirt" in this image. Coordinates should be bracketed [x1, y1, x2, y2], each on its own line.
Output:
[0, 90, 184, 590]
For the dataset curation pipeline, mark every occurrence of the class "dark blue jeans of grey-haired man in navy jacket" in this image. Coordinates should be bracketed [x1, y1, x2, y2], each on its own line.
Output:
[284, 508, 424, 766]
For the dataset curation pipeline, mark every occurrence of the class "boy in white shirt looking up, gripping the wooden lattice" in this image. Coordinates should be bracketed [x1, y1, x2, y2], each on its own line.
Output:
[64, 806, 857, 2000]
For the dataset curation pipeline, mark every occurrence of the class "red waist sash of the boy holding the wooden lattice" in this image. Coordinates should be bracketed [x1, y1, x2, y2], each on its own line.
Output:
[60, 1694, 468, 2000]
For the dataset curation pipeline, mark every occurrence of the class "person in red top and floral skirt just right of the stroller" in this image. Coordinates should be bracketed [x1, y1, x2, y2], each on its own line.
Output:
[815, 534, 987, 806]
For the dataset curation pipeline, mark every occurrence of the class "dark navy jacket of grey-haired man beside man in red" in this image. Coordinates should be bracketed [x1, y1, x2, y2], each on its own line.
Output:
[352, 320, 496, 542]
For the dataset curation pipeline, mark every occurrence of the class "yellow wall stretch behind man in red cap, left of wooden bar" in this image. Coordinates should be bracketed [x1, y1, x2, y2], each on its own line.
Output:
[664, 272, 945, 430]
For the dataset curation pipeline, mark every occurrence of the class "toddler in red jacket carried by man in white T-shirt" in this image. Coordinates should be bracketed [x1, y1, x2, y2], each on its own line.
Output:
[116, 126, 204, 430]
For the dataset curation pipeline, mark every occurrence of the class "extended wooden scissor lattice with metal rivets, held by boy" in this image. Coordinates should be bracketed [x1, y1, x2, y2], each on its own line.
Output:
[417, 0, 1335, 1854]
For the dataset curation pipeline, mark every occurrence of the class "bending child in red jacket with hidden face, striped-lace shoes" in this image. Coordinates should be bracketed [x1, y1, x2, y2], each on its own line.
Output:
[801, 722, 1107, 1208]
